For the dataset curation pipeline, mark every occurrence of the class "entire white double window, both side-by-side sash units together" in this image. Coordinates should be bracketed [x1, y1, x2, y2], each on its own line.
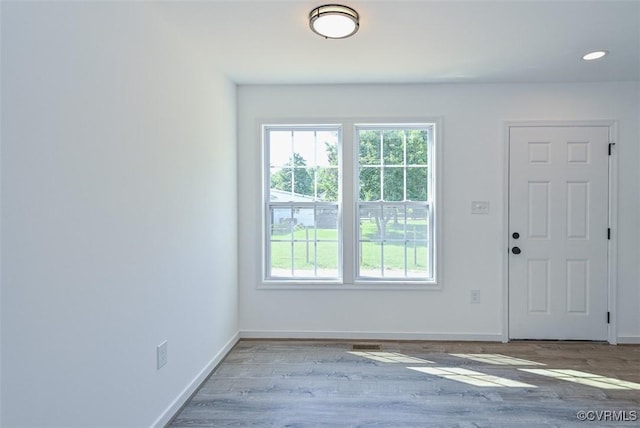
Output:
[262, 121, 437, 285]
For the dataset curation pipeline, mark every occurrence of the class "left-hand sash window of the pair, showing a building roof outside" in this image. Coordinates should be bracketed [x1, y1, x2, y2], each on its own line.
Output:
[264, 125, 341, 280]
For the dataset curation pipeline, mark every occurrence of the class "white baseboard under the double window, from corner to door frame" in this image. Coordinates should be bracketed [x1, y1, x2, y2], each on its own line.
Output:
[240, 330, 503, 342]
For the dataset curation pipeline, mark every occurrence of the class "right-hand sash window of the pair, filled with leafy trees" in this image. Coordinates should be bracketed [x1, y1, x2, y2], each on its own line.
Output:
[356, 125, 433, 281]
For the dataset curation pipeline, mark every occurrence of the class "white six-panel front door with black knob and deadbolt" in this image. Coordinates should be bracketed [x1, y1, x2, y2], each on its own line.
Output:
[509, 126, 610, 340]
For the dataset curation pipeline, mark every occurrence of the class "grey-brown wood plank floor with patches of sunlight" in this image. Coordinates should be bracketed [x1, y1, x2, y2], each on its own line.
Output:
[170, 340, 640, 428]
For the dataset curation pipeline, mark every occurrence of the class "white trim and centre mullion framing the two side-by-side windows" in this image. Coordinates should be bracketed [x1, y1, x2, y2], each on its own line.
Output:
[256, 117, 444, 291]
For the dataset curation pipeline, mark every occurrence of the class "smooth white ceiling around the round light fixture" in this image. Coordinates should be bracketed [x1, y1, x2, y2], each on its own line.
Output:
[153, 0, 640, 84]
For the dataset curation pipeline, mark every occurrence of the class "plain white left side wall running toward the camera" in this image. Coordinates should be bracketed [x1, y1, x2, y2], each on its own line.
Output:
[0, 2, 238, 428]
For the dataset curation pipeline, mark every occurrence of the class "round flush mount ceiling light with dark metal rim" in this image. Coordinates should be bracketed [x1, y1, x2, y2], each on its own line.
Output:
[309, 4, 360, 39]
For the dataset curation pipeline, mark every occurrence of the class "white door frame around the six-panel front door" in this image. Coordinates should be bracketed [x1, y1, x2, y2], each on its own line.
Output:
[502, 120, 618, 345]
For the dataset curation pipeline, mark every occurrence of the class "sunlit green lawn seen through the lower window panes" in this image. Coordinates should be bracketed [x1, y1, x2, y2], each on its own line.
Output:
[271, 220, 428, 275]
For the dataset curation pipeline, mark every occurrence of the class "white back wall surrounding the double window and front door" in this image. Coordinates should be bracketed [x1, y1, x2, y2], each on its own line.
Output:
[238, 83, 640, 341]
